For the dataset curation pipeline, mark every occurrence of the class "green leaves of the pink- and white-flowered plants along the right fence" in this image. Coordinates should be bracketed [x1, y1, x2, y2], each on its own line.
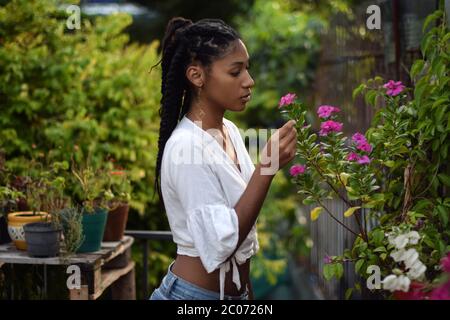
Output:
[283, 10, 450, 295]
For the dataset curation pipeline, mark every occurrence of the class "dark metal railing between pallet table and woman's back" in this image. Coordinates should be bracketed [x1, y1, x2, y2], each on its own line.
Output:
[125, 230, 172, 297]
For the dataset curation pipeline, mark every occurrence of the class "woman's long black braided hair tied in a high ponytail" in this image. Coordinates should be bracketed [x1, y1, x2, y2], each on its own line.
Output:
[154, 17, 240, 201]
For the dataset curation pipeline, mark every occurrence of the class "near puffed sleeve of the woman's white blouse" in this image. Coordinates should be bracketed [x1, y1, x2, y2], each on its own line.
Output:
[170, 136, 239, 273]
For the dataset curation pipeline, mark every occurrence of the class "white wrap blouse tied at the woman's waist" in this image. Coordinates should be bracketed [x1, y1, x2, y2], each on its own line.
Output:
[161, 116, 259, 300]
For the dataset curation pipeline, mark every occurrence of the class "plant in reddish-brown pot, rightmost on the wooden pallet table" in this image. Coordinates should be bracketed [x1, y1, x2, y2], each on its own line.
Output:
[103, 170, 131, 241]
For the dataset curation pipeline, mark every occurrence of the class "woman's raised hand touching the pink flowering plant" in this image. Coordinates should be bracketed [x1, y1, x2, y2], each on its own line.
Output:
[260, 120, 297, 175]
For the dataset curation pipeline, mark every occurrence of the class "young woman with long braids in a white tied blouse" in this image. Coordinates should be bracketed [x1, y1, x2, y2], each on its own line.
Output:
[150, 18, 297, 300]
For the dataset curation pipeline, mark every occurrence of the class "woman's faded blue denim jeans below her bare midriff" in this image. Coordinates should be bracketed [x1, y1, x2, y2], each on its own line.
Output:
[150, 261, 248, 300]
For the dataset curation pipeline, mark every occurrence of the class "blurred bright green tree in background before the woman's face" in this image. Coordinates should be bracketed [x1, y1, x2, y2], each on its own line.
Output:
[236, 0, 324, 127]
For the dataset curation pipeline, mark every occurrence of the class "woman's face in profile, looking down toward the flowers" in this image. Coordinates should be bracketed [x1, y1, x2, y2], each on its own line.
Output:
[201, 40, 255, 111]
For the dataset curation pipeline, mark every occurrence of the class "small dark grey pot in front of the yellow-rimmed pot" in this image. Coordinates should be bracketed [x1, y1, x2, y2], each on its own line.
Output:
[23, 222, 61, 258]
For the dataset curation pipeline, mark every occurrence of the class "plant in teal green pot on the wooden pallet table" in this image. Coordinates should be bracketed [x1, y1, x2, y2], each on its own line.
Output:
[71, 157, 112, 253]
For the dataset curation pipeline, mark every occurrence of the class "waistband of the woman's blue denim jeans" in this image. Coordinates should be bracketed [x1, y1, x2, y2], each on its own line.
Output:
[161, 261, 248, 300]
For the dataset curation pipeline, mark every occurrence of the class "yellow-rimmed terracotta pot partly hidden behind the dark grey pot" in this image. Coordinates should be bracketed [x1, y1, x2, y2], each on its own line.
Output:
[8, 211, 50, 250]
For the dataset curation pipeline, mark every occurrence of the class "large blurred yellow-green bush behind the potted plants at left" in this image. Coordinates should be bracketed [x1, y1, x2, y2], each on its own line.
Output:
[0, 0, 160, 218]
